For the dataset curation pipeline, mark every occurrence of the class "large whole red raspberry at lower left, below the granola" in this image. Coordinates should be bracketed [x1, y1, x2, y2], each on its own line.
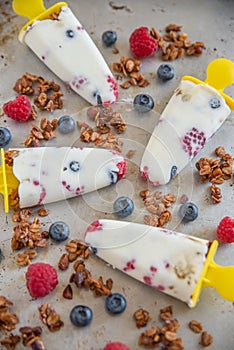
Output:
[26, 262, 58, 298]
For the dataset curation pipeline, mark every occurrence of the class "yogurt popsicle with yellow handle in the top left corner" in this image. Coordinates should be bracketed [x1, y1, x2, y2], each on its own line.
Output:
[13, 0, 118, 105]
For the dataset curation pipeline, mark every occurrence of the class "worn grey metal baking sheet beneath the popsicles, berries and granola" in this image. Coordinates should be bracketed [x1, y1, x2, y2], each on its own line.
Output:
[0, 0, 234, 350]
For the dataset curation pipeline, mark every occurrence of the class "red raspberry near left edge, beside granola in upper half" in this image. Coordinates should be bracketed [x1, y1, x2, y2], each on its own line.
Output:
[3, 95, 32, 122]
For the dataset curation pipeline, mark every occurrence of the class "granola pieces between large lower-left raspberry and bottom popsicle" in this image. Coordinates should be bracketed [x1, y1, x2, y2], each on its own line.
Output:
[58, 240, 113, 299]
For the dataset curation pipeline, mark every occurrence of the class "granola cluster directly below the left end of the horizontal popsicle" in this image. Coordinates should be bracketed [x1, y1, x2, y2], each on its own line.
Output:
[11, 209, 49, 266]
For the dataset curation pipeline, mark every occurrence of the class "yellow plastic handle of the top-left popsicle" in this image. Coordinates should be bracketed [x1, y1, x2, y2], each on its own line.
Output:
[12, 0, 67, 38]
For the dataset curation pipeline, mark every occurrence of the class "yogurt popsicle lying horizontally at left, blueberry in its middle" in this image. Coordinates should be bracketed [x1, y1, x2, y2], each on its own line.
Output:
[1, 147, 126, 208]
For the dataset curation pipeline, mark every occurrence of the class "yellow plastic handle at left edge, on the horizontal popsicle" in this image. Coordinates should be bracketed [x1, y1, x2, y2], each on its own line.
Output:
[0, 148, 19, 213]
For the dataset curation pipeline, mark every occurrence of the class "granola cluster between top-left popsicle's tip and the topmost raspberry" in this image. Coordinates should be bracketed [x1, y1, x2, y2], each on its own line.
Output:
[113, 56, 149, 89]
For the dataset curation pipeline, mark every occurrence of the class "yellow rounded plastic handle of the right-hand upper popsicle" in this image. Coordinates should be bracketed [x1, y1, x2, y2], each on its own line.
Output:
[182, 58, 234, 110]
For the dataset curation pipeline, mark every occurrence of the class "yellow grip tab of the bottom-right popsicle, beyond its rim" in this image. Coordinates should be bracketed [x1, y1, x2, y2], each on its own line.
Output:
[203, 261, 234, 302]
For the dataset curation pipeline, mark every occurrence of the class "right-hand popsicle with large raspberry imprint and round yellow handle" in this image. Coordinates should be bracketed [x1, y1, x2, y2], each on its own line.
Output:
[140, 59, 234, 186]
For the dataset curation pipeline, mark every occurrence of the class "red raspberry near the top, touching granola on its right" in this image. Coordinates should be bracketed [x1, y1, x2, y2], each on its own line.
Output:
[129, 27, 158, 58]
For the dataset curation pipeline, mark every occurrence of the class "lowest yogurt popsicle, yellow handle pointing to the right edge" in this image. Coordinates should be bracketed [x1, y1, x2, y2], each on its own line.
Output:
[85, 220, 234, 307]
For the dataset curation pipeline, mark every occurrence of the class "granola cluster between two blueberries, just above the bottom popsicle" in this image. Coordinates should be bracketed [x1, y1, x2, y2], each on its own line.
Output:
[140, 189, 176, 227]
